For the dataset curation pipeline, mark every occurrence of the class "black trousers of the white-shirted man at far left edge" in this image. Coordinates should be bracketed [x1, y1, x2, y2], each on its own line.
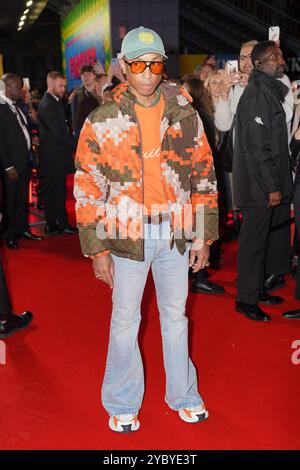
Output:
[4, 168, 30, 240]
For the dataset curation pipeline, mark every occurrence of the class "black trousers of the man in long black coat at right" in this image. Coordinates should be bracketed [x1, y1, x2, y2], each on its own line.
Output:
[237, 205, 290, 304]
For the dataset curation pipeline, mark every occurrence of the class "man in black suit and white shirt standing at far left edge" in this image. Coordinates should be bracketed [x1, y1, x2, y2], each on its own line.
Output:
[0, 73, 42, 249]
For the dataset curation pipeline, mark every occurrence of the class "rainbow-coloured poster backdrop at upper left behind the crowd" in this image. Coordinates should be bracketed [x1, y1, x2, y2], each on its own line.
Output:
[61, 0, 111, 90]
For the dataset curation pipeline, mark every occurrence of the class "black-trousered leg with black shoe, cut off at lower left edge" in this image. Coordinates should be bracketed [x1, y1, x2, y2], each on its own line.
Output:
[0, 180, 33, 339]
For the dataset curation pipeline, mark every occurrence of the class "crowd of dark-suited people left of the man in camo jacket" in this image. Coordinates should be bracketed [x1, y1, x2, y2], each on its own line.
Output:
[0, 58, 129, 338]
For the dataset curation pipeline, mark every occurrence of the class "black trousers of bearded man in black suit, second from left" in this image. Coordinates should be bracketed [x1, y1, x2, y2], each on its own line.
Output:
[43, 168, 68, 229]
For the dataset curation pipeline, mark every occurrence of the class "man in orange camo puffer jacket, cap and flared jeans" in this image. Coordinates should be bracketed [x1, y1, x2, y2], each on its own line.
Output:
[74, 27, 218, 432]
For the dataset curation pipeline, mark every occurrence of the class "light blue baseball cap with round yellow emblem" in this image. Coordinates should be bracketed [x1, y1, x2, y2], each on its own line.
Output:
[121, 26, 168, 60]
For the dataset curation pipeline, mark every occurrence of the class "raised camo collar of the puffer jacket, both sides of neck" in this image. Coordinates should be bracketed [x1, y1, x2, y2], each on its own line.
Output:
[113, 81, 196, 125]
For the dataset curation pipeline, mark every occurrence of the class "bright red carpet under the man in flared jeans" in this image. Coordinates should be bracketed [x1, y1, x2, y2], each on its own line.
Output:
[0, 177, 300, 450]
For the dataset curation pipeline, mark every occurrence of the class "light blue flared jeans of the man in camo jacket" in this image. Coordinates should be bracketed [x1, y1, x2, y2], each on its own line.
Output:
[102, 221, 203, 416]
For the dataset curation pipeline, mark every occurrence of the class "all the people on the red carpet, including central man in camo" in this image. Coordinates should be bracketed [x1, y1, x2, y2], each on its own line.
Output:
[0, 27, 300, 432]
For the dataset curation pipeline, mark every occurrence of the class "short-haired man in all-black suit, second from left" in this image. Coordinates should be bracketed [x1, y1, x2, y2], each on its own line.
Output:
[39, 71, 77, 235]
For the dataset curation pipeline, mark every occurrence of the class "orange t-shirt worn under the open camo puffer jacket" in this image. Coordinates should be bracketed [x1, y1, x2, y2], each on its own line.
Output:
[135, 94, 168, 214]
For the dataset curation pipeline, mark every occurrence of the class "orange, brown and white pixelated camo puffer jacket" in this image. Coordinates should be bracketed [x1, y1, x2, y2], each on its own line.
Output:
[74, 82, 218, 260]
